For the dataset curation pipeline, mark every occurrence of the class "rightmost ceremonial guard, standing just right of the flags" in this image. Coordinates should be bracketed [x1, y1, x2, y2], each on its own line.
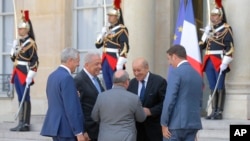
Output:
[199, 0, 234, 120]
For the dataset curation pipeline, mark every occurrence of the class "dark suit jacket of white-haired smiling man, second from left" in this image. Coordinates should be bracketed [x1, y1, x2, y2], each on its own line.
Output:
[74, 69, 104, 139]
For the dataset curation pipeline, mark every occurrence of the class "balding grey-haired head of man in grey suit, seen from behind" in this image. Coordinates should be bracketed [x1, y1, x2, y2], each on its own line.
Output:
[113, 70, 129, 84]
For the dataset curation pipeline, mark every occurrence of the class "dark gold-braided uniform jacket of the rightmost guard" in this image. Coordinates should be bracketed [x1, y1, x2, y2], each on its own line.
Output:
[200, 22, 234, 72]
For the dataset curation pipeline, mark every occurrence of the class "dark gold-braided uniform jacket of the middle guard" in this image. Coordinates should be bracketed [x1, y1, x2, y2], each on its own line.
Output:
[95, 24, 129, 70]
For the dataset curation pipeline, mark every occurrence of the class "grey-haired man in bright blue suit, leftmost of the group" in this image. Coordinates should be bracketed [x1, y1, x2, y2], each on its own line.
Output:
[41, 48, 85, 141]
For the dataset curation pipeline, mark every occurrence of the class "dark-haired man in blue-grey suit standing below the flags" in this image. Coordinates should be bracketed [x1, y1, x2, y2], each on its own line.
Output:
[161, 45, 202, 141]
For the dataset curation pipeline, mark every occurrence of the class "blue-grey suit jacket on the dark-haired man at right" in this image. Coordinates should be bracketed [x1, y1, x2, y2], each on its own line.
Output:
[161, 62, 202, 129]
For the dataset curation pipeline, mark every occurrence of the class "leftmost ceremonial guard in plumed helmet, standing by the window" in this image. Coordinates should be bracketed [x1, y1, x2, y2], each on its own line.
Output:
[10, 10, 38, 131]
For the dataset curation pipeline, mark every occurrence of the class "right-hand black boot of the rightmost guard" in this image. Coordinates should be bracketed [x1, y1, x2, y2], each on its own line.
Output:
[214, 89, 226, 120]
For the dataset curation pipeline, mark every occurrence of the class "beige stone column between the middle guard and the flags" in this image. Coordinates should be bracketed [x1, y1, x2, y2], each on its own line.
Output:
[154, 0, 174, 78]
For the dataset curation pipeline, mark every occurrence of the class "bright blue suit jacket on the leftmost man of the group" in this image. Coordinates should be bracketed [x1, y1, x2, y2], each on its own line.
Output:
[41, 67, 84, 137]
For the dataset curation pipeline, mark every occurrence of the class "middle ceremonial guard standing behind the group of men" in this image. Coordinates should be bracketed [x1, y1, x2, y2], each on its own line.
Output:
[95, 0, 129, 89]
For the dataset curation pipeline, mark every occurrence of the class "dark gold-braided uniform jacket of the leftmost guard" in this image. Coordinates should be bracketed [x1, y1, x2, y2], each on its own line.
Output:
[11, 36, 39, 85]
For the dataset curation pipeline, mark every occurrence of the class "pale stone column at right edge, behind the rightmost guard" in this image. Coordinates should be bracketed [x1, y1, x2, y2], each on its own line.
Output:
[223, 0, 250, 119]
